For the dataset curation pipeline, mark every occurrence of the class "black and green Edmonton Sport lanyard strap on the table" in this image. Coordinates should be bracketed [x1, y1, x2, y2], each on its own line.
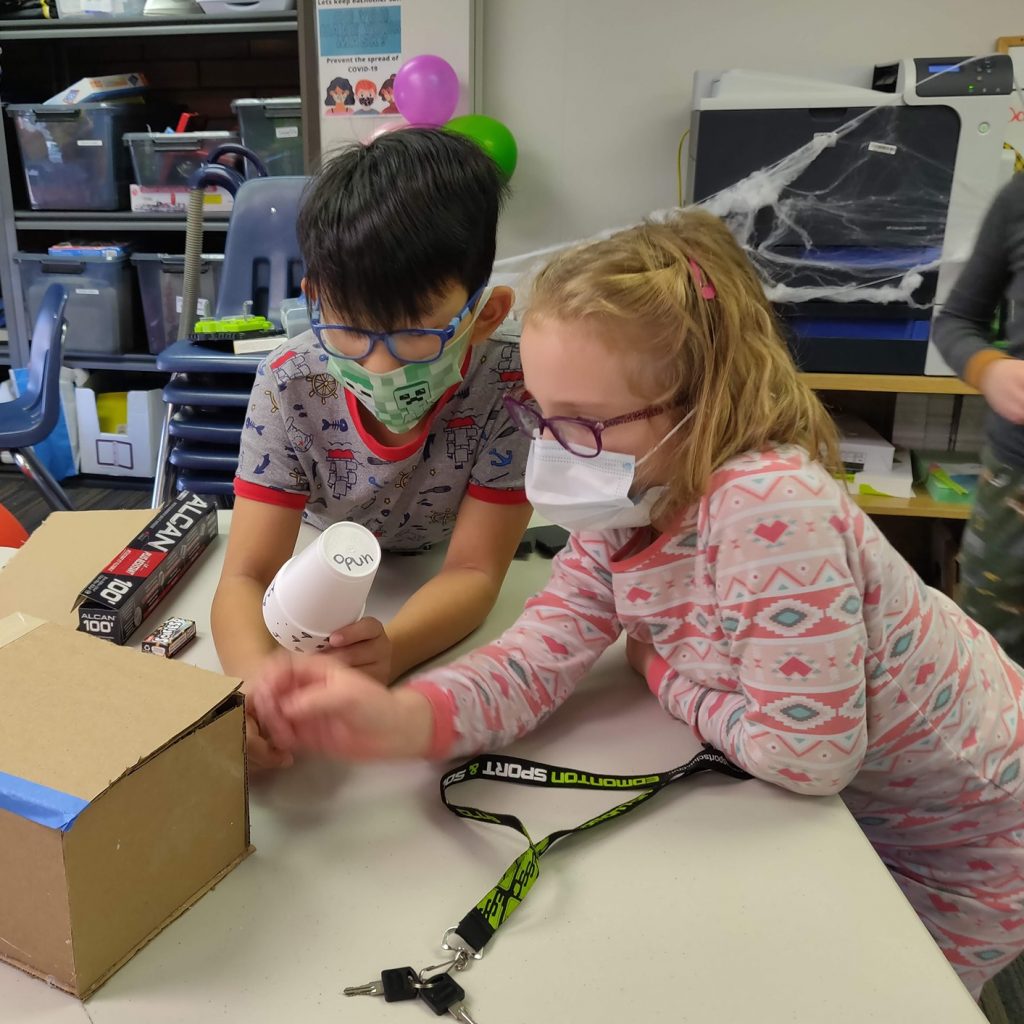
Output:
[441, 745, 751, 952]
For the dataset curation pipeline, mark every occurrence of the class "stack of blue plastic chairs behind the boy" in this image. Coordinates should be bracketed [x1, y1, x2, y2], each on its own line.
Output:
[153, 177, 306, 505]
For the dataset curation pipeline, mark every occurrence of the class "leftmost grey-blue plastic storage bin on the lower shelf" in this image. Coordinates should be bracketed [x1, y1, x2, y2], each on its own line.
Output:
[14, 253, 135, 355]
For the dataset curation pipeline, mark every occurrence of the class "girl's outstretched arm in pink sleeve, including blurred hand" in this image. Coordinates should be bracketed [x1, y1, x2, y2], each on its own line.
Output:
[253, 538, 622, 760]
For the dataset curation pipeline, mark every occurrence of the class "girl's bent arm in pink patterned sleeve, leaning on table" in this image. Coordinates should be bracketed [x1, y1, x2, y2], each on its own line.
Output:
[646, 470, 864, 795]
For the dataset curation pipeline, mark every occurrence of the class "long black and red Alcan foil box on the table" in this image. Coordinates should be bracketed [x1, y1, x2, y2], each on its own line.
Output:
[78, 490, 217, 644]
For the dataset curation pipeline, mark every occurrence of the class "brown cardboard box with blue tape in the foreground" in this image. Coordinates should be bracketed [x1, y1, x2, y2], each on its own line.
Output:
[0, 615, 250, 995]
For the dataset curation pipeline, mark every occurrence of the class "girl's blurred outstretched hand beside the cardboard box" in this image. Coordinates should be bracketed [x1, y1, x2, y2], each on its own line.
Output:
[253, 655, 433, 761]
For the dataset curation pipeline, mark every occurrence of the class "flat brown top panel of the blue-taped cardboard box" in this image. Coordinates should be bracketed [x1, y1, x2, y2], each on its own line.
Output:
[0, 614, 238, 801]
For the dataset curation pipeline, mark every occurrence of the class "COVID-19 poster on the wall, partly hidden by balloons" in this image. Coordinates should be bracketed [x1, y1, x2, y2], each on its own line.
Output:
[316, 0, 478, 153]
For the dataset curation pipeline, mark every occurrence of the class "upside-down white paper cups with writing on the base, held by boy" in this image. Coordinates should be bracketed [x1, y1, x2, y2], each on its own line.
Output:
[263, 522, 381, 649]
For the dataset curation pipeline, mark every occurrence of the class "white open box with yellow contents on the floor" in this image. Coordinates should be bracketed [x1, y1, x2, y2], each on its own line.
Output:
[75, 387, 164, 476]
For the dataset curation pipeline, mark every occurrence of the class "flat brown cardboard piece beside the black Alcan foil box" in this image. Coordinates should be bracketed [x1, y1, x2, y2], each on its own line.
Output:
[0, 509, 154, 627]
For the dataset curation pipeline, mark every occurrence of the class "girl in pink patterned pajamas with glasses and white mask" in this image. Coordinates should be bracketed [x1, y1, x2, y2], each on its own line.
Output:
[247, 211, 1024, 997]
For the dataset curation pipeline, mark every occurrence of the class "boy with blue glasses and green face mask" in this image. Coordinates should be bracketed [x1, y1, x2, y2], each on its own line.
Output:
[212, 128, 530, 767]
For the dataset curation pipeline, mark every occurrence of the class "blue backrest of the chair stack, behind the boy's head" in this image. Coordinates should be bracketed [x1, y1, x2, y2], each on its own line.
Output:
[216, 177, 308, 327]
